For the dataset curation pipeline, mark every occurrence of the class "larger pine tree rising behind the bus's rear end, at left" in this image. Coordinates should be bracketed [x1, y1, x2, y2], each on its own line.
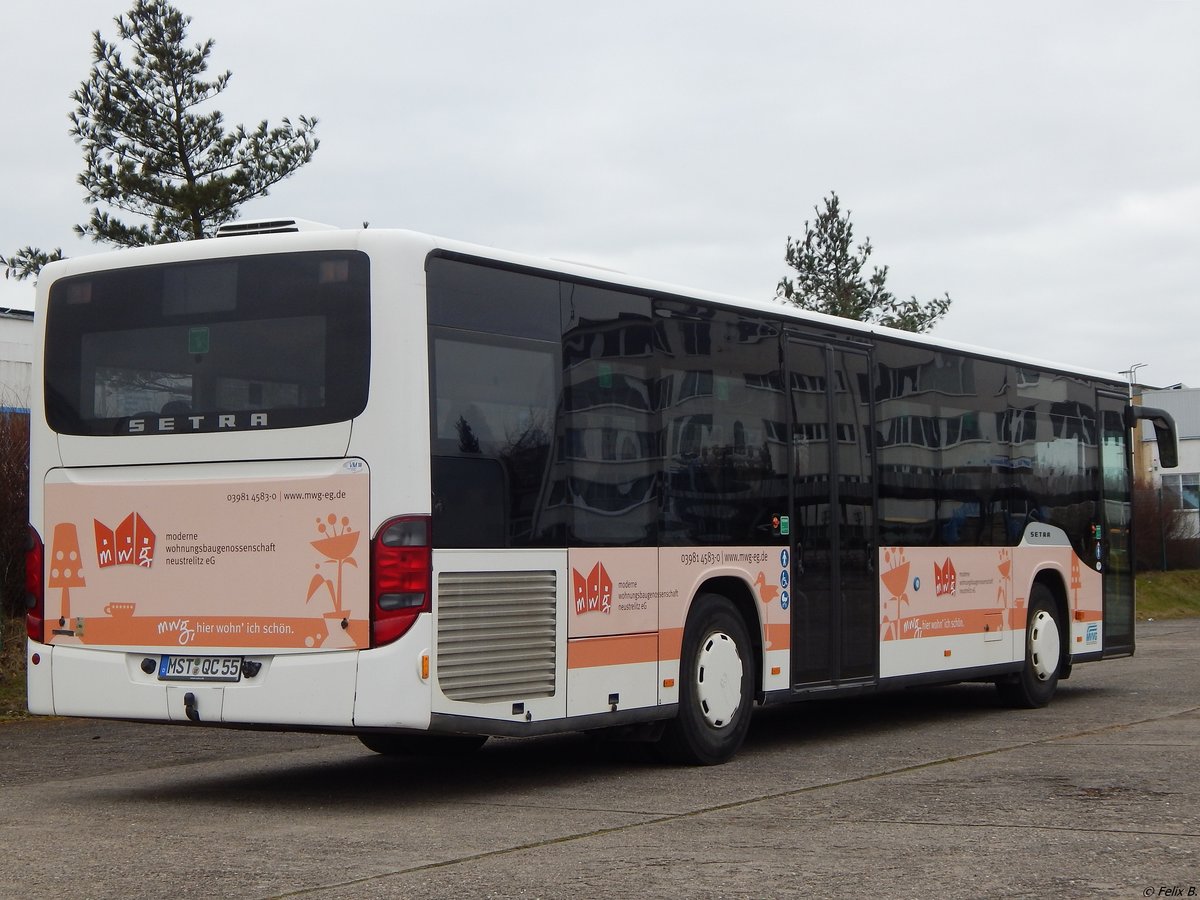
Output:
[0, 0, 319, 280]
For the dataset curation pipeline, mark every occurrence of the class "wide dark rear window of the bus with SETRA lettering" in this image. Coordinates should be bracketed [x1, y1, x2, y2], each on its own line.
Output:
[46, 251, 371, 434]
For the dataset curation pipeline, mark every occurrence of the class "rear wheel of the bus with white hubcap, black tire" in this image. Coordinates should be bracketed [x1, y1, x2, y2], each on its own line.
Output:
[658, 594, 754, 766]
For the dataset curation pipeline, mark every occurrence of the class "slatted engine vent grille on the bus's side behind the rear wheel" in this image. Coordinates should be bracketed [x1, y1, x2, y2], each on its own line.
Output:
[437, 570, 558, 703]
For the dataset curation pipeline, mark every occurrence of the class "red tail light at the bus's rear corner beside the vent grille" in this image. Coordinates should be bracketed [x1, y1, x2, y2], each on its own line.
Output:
[371, 516, 433, 647]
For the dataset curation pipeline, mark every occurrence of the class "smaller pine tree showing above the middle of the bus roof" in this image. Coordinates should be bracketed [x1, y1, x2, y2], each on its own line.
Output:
[775, 193, 950, 332]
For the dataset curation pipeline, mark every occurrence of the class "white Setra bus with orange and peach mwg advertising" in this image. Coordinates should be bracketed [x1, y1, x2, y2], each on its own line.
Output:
[26, 221, 1175, 764]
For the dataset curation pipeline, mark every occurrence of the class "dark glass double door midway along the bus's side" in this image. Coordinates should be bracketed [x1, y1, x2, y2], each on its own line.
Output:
[787, 338, 878, 689]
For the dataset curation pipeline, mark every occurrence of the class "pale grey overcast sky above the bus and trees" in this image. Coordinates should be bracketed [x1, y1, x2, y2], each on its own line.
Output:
[0, 0, 1200, 386]
